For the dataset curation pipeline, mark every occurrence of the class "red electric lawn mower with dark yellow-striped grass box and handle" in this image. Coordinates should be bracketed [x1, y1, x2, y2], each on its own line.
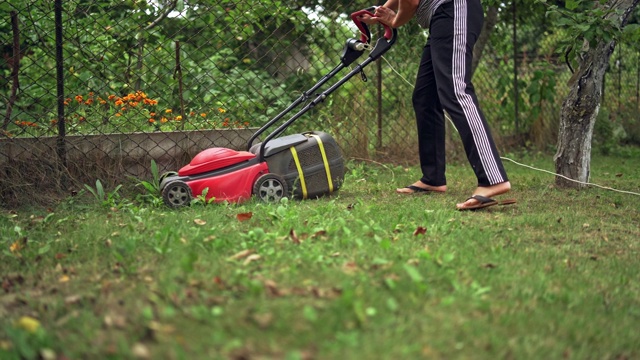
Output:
[160, 8, 397, 208]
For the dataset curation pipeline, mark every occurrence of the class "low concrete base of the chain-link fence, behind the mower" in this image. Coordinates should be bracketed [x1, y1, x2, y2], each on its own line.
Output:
[0, 129, 257, 178]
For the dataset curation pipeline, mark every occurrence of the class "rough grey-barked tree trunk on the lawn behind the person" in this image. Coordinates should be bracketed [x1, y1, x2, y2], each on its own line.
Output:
[554, 0, 640, 188]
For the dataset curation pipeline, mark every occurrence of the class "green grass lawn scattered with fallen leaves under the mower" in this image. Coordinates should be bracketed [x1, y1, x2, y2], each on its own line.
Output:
[0, 149, 640, 359]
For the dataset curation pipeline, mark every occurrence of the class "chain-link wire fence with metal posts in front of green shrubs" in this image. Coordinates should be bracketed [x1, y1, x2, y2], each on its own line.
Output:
[0, 0, 640, 206]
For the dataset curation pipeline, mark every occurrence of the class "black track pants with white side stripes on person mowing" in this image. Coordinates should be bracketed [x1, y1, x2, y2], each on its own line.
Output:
[413, 0, 508, 186]
